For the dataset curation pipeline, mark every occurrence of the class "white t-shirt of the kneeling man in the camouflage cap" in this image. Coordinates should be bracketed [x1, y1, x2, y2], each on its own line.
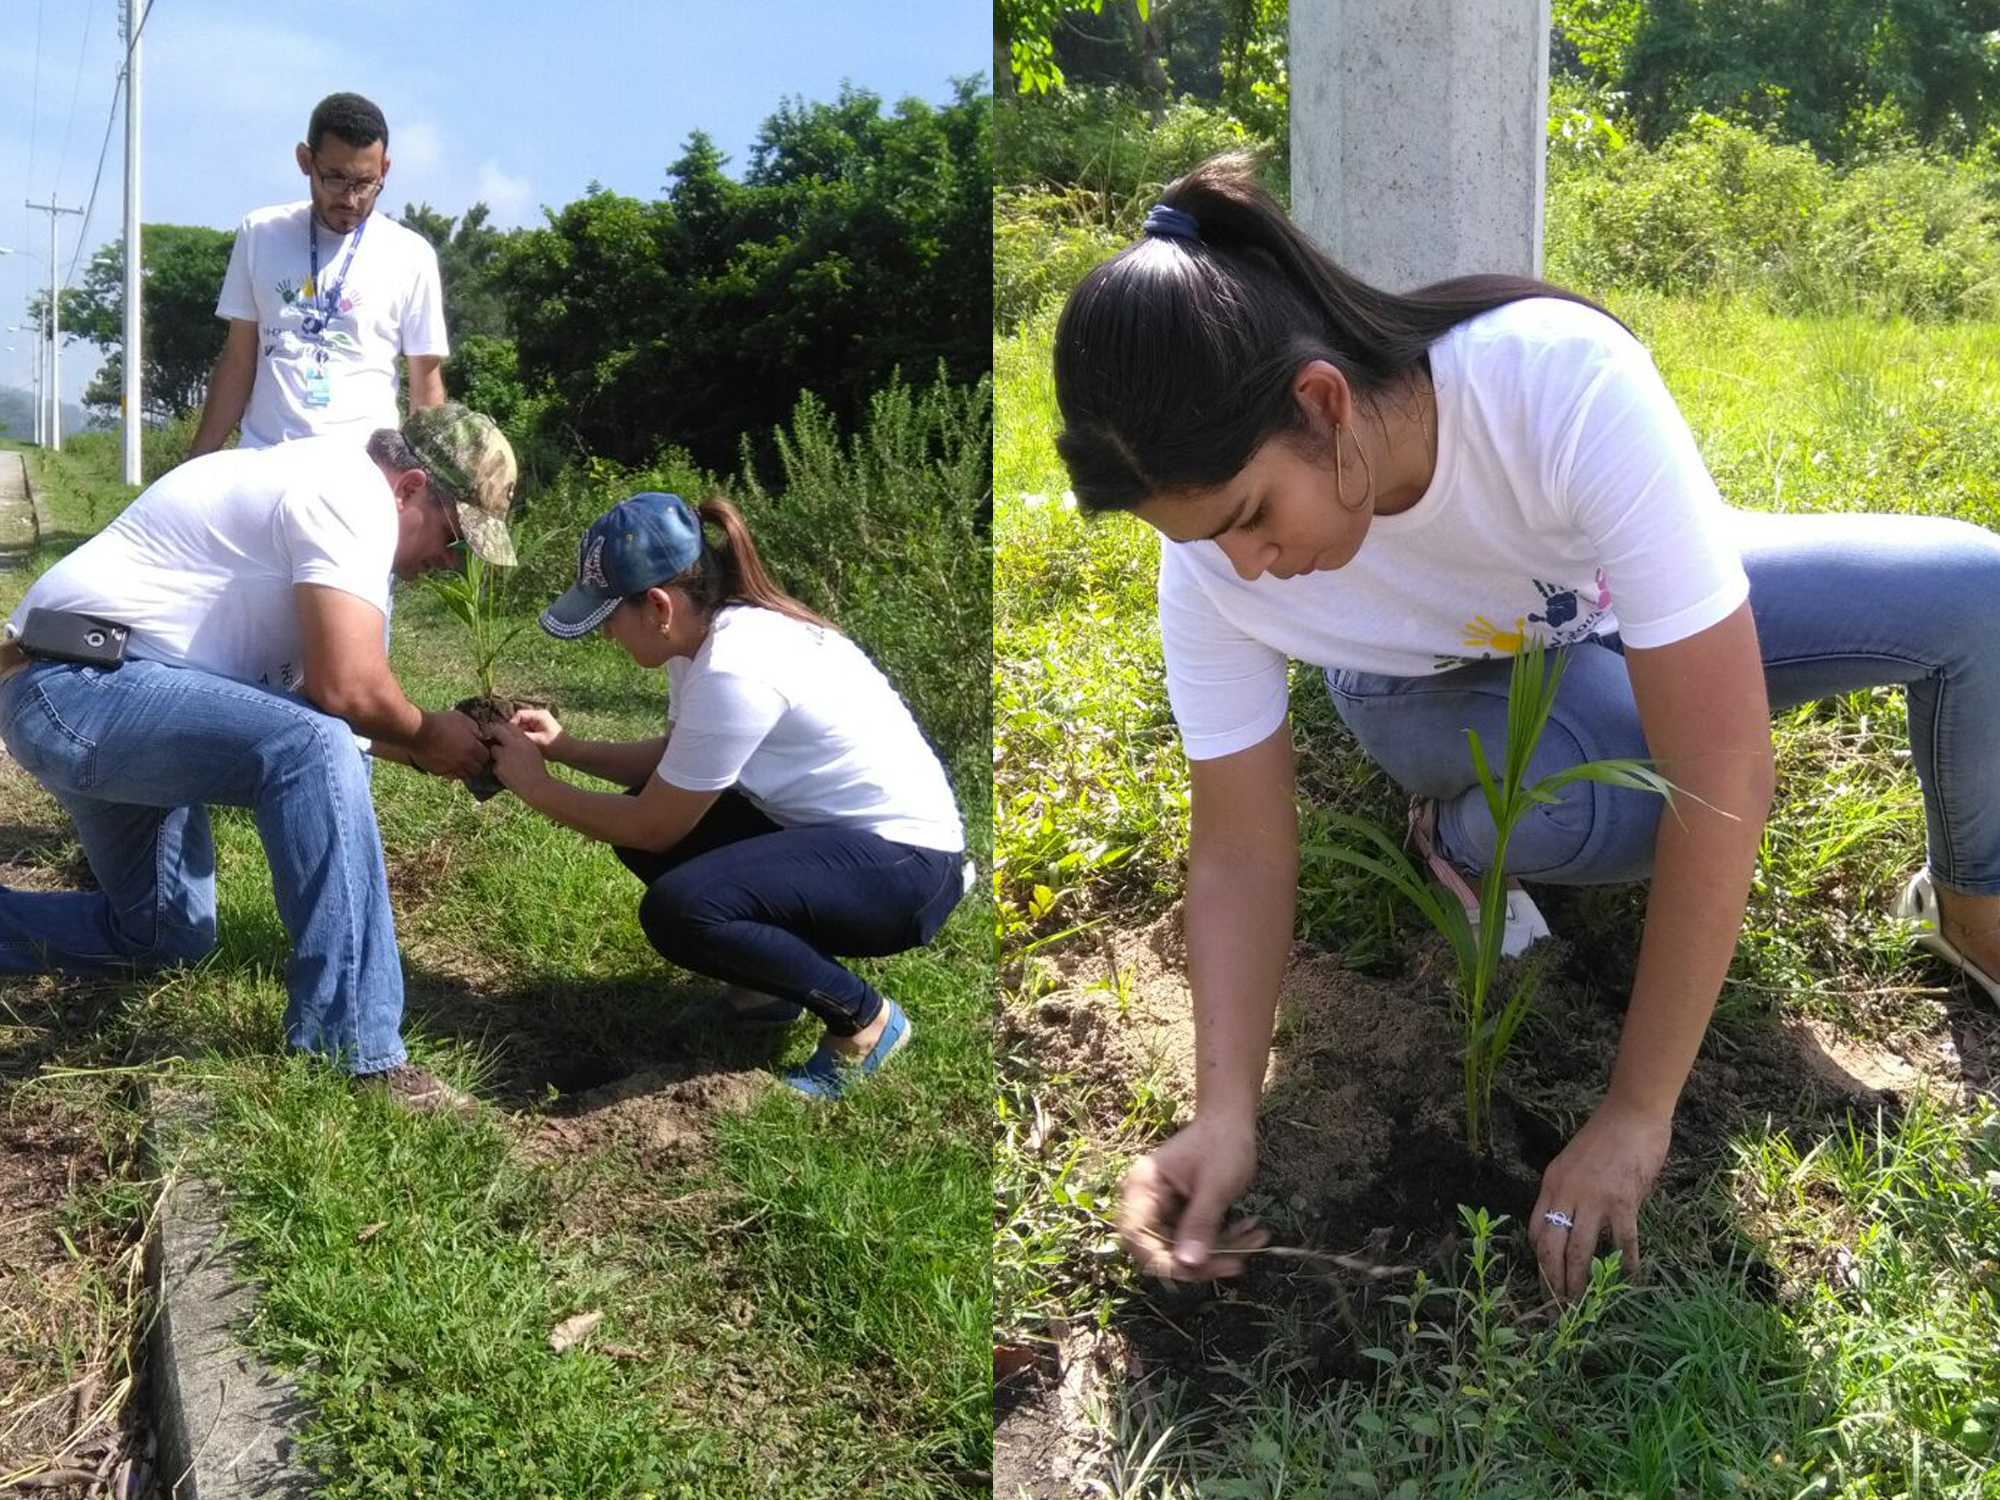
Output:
[14, 438, 398, 692]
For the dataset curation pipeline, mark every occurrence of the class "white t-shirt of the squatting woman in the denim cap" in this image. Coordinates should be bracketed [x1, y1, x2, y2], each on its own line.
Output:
[660, 604, 966, 854]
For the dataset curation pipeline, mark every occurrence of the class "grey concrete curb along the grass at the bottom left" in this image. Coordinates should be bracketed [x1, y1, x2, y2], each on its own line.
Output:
[146, 1088, 316, 1500]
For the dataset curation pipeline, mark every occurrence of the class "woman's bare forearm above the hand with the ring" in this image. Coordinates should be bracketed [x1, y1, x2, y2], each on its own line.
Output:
[1606, 766, 1770, 1120]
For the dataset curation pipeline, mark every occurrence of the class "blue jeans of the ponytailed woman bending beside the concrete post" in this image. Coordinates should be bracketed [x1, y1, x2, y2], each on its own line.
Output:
[1326, 514, 2000, 896]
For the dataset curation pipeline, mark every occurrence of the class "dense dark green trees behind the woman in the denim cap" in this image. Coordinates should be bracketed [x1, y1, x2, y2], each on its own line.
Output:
[498, 82, 992, 468]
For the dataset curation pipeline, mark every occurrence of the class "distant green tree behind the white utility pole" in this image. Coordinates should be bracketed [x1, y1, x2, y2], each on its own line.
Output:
[62, 224, 236, 420]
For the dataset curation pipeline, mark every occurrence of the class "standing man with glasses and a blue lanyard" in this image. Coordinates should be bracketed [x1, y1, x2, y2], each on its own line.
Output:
[188, 94, 450, 458]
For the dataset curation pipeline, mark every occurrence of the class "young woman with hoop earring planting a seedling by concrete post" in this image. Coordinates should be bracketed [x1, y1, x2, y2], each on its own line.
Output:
[1054, 158, 2000, 1296]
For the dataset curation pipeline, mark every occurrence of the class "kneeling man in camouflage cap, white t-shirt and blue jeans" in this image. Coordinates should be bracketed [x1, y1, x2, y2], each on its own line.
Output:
[0, 404, 514, 1108]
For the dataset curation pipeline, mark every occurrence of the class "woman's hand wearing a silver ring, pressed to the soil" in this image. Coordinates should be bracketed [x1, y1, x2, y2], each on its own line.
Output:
[1528, 1100, 1674, 1302]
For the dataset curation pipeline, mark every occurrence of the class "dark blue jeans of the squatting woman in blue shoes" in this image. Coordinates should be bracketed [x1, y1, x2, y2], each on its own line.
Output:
[616, 790, 964, 1036]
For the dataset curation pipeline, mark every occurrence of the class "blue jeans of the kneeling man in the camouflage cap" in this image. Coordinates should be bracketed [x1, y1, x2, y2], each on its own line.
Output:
[0, 660, 404, 1072]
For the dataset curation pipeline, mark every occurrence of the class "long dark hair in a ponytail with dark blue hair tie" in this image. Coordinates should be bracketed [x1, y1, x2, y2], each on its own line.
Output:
[1056, 152, 1608, 510]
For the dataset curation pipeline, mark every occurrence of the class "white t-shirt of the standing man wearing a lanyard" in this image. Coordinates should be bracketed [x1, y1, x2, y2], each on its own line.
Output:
[216, 202, 450, 448]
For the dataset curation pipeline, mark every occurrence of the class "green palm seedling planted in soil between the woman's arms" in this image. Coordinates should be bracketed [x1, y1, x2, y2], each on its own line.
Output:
[1314, 638, 1674, 1156]
